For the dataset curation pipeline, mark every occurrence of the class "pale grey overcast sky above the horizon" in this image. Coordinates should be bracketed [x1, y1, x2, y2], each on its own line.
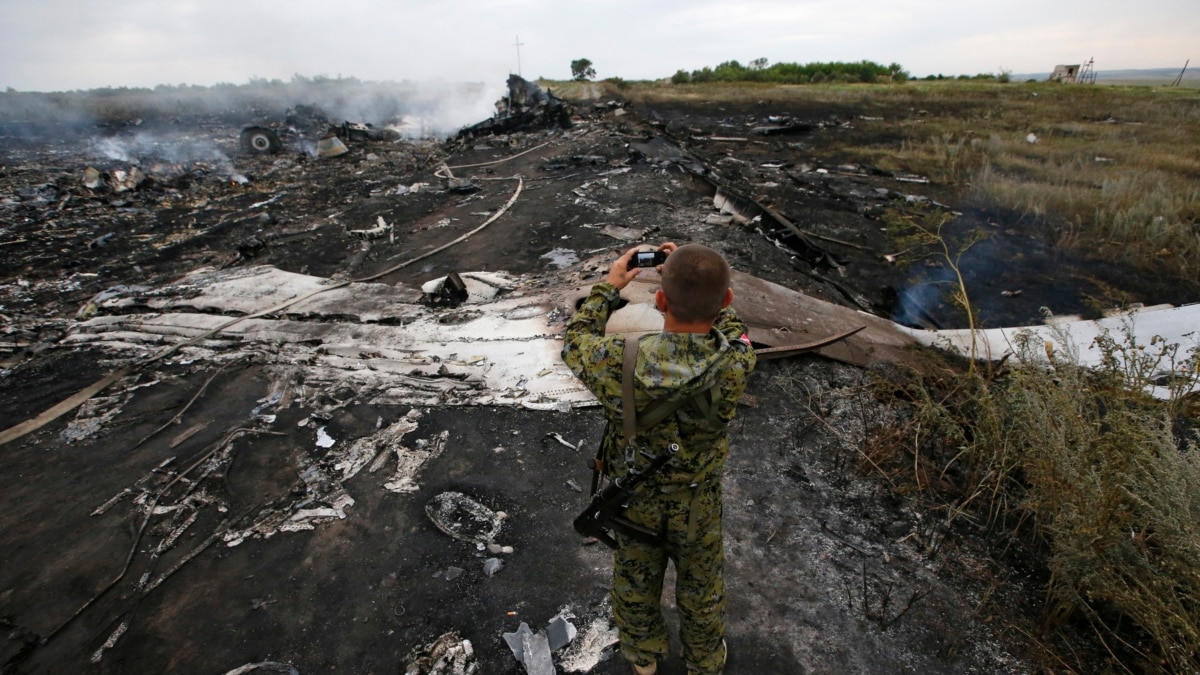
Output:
[0, 0, 1200, 91]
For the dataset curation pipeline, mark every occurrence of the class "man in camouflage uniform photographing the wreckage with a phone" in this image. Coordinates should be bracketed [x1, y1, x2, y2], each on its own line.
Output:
[563, 243, 755, 675]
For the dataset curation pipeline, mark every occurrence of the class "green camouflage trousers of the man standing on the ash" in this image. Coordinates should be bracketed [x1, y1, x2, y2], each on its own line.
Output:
[612, 477, 725, 674]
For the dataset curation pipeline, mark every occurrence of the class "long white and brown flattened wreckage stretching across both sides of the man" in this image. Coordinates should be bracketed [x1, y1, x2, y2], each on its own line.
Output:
[7, 235, 1200, 443]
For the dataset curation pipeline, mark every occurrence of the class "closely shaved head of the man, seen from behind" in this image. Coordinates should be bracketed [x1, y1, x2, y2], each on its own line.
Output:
[662, 244, 730, 322]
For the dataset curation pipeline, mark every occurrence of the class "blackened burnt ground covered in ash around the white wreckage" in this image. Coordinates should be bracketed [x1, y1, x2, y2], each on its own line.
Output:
[0, 85, 1196, 674]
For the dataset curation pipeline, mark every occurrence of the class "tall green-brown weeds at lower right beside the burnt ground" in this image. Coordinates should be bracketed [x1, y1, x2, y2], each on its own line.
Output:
[869, 325, 1200, 673]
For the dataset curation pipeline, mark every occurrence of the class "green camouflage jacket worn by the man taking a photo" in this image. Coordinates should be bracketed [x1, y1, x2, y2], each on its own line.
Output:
[563, 282, 756, 484]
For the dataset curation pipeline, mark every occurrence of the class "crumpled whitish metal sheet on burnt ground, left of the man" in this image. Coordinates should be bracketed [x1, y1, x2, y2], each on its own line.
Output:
[65, 267, 594, 410]
